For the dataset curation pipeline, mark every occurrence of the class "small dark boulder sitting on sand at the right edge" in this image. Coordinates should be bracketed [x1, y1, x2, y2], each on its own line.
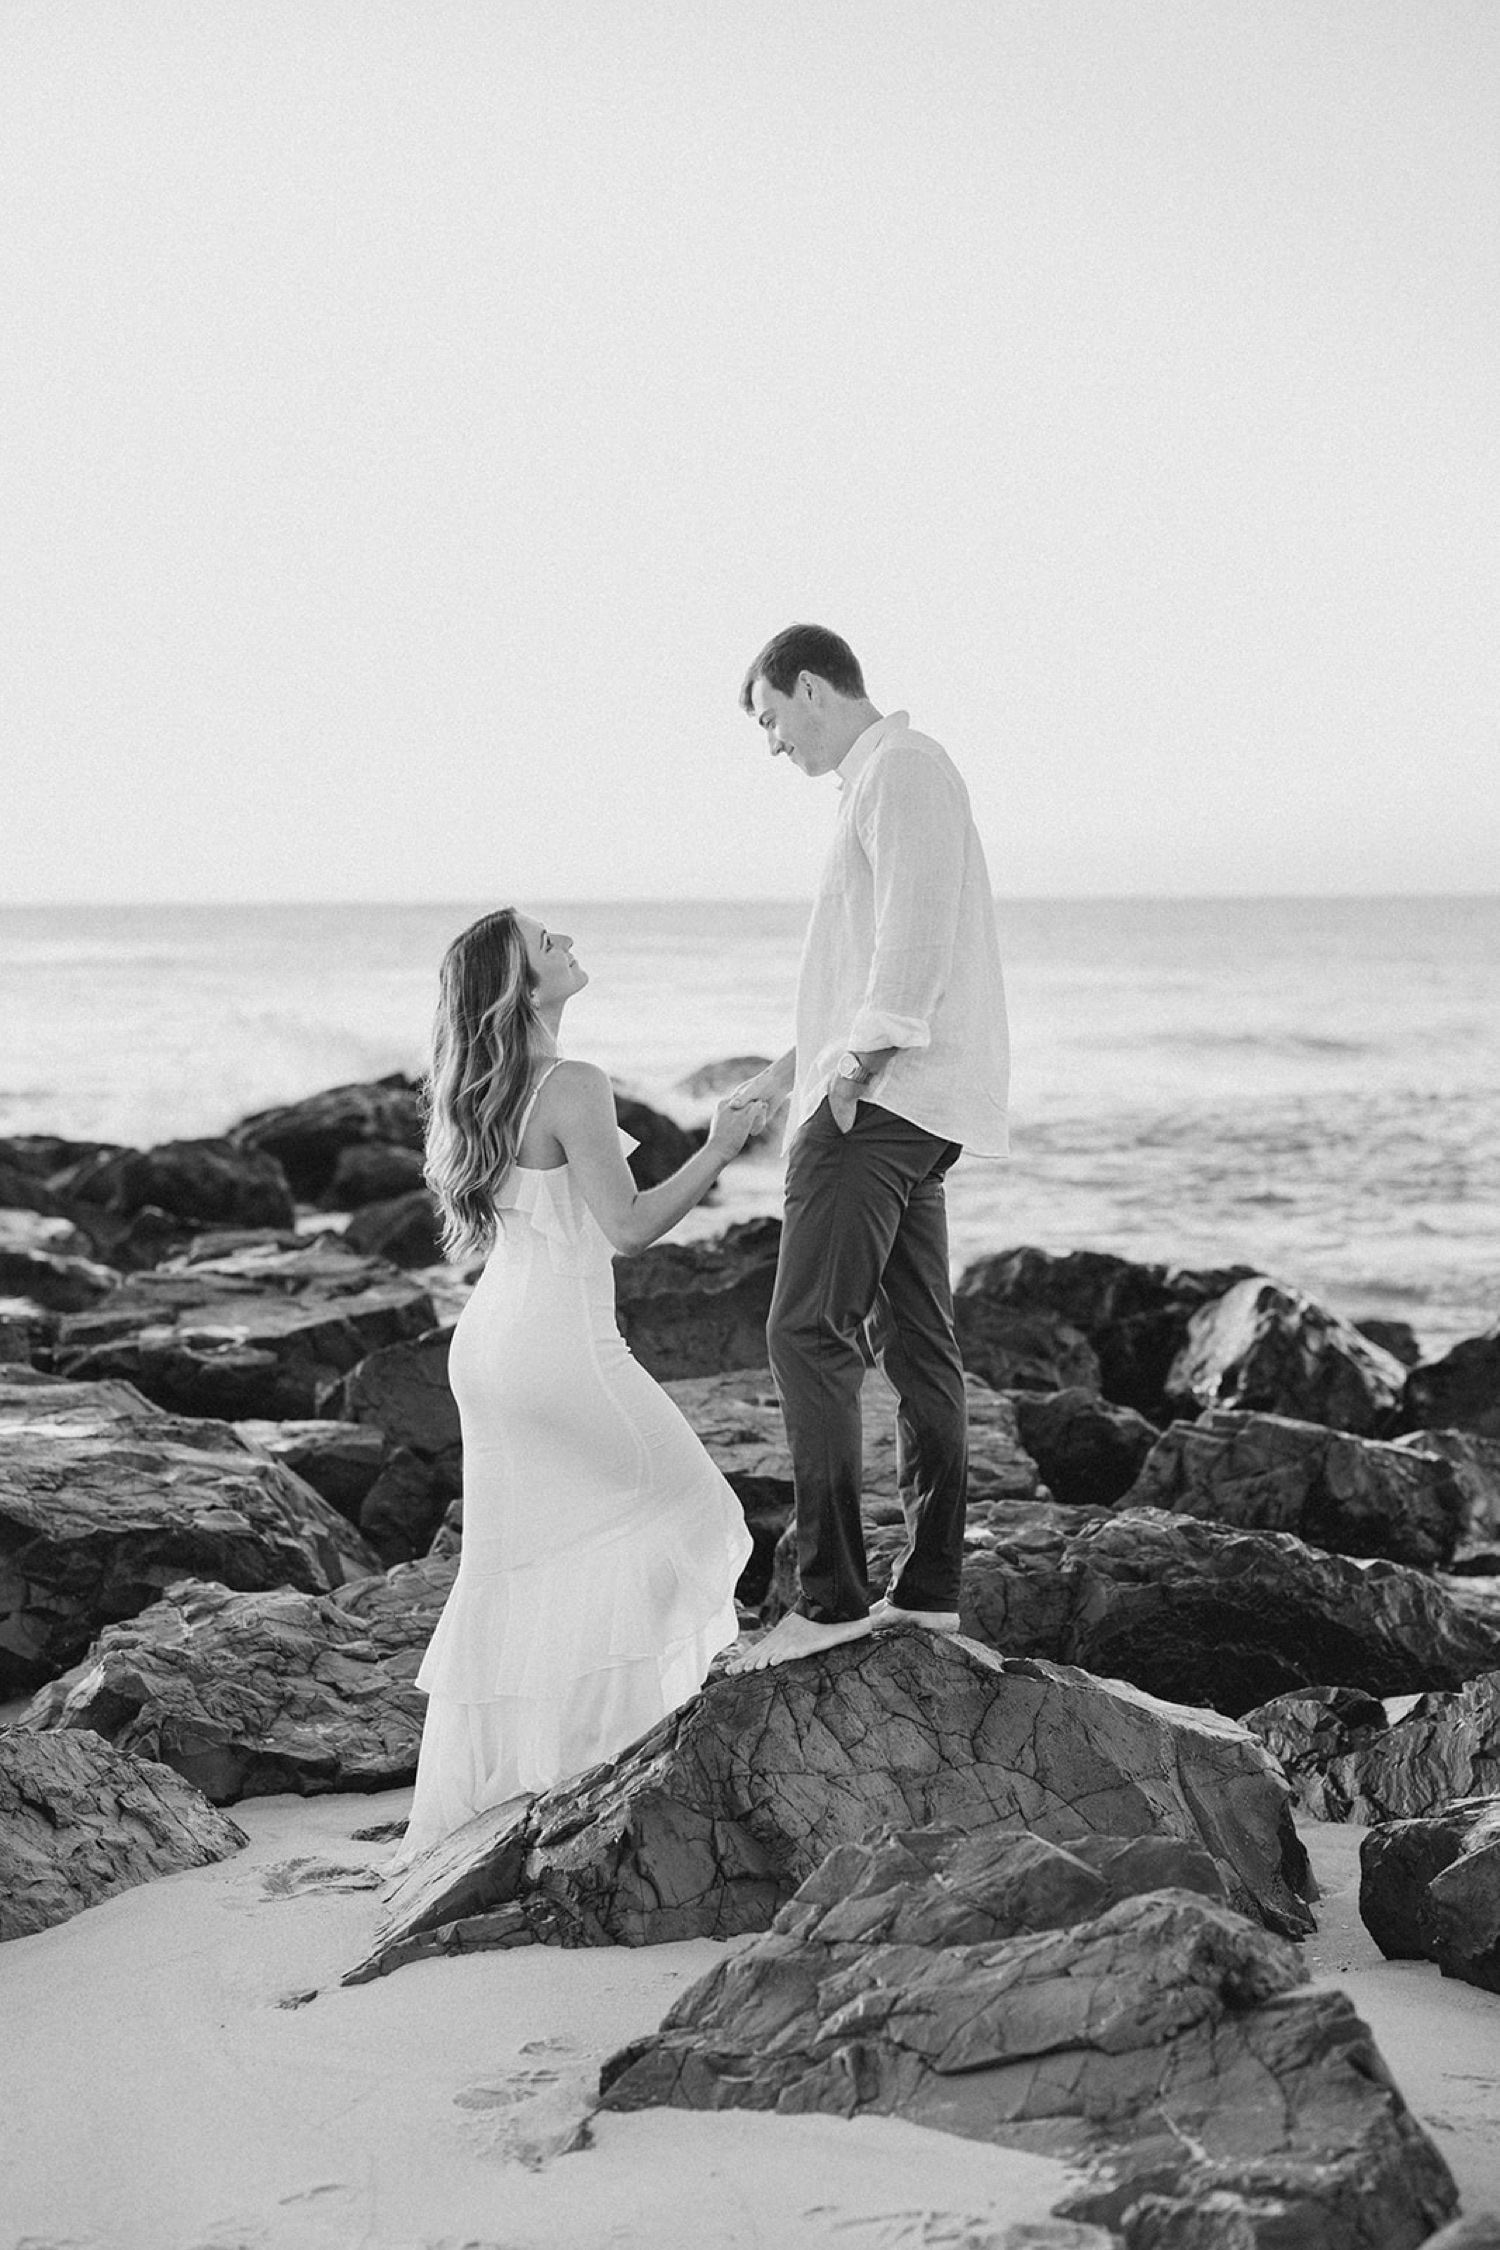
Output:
[1358, 1793, 1500, 1991]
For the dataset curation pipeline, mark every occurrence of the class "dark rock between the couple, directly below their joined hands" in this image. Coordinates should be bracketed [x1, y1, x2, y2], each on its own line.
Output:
[614, 1220, 780, 1382]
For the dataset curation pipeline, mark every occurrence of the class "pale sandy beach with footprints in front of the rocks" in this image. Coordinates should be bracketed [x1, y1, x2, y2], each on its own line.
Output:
[0, 1791, 1500, 2250]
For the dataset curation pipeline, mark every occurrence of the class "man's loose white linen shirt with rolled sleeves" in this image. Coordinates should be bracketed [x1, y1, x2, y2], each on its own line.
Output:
[787, 711, 1010, 1157]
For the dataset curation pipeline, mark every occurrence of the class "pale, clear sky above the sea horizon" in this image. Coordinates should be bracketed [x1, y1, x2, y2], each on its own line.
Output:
[0, 0, 1500, 900]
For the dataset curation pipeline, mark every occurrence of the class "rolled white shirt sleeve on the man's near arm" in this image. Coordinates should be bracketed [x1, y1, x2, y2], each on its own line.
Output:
[848, 747, 969, 1053]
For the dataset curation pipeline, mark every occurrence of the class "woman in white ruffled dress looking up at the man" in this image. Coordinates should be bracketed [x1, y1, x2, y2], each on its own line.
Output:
[400, 907, 765, 1863]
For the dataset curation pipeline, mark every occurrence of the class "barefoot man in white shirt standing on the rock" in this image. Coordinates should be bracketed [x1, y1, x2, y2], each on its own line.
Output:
[729, 626, 1007, 1672]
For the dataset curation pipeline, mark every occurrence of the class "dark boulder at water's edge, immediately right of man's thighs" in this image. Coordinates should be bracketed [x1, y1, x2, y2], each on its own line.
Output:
[956, 1247, 1253, 1422]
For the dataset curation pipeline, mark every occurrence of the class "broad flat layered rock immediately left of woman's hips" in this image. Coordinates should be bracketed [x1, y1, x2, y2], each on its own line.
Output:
[52, 1240, 436, 1422]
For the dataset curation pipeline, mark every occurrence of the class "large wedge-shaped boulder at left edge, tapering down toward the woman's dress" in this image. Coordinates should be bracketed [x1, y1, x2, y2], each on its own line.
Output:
[0, 1384, 376, 1697]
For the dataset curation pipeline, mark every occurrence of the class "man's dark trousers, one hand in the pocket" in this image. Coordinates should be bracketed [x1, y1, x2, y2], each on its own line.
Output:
[767, 1100, 969, 1625]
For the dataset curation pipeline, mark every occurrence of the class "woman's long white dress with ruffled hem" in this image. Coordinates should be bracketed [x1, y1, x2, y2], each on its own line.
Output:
[396, 1087, 751, 1865]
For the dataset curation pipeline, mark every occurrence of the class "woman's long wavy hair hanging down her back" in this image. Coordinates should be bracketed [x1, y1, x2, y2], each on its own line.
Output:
[425, 907, 544, 1258]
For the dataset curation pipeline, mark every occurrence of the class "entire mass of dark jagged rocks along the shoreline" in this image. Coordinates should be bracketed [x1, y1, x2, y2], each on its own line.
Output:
[0, 1080, 1500, 2250]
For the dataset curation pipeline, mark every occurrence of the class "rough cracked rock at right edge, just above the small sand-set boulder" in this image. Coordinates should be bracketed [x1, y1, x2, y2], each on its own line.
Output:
[1246, 1670, 1500, 1823]
